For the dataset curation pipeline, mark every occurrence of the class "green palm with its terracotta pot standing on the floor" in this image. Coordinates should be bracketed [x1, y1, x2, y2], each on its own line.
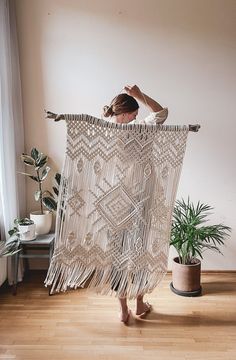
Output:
[170, 198, 231, 296]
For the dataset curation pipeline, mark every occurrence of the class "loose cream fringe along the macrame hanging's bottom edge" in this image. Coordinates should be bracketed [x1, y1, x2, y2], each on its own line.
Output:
[45, 262, 166, 299]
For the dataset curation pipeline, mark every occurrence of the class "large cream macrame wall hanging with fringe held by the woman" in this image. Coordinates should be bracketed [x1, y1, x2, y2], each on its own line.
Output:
[45, 113, 199, 299]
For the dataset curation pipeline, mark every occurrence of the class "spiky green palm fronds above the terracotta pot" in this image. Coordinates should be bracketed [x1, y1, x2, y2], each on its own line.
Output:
[170, 198, 231, 265]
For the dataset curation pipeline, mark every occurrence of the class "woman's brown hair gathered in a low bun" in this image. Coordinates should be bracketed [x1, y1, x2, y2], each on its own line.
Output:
[103, 94, 139, 117]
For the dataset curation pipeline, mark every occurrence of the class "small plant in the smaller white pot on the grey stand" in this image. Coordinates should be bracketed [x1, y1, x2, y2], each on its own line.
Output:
[8, 218, 36, 241]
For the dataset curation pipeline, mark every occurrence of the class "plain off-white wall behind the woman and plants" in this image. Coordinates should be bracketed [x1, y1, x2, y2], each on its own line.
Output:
[16, 0, 236, 270]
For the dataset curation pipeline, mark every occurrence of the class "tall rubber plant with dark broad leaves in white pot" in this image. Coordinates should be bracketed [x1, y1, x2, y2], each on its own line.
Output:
[21, 148, 60, 235]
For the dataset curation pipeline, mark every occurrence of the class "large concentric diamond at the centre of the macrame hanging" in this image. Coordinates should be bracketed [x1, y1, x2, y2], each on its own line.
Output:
[97, 186, 137, 227]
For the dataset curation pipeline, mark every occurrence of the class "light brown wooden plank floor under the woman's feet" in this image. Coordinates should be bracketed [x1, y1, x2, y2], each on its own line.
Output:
[0, 271, 236, 360]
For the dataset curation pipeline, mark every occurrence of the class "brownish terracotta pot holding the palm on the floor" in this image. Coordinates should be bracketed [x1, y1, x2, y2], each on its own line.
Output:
[171, 257, 201, 296]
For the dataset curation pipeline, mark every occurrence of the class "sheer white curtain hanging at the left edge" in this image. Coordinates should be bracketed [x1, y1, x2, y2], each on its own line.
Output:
[0, 0, 25, 283]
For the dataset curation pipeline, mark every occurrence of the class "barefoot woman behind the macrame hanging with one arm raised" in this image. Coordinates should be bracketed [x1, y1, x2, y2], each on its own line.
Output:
[103, 85, 168, 324]
